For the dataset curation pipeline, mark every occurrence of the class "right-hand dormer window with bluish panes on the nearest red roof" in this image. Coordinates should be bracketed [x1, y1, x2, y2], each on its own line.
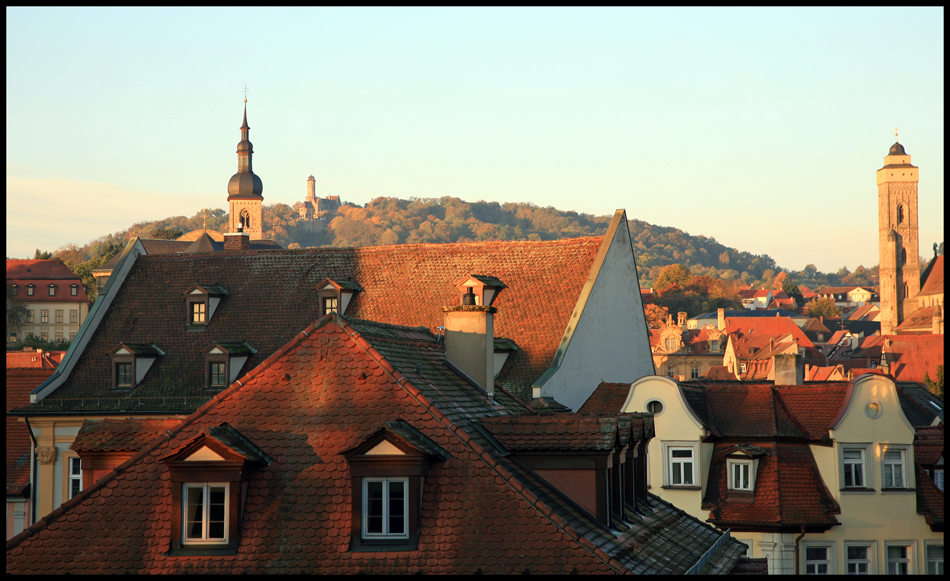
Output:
[343, 420, 450, 552]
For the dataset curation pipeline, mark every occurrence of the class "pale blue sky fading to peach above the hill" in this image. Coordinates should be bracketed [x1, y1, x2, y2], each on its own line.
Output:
[6, 7, 944, 272]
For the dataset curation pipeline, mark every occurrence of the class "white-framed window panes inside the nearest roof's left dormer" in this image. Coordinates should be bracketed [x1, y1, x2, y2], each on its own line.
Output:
[181, 482, 229, 545]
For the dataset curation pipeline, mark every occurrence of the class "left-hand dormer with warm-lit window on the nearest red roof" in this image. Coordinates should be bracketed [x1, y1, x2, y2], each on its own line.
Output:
[162, 423, 273, 556]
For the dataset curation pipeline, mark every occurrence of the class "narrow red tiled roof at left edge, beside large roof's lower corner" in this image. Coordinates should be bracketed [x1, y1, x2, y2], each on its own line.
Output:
[6, 367, 53, 495]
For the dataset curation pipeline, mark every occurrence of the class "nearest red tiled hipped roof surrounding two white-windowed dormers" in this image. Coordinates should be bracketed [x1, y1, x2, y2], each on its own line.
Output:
[1, 315, 761, 574]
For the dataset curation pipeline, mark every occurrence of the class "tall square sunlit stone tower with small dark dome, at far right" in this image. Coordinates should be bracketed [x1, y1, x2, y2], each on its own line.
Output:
[877, 133, 920, 335]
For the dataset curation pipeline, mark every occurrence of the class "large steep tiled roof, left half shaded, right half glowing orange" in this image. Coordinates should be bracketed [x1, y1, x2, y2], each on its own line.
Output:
[20, 237, 603, 413]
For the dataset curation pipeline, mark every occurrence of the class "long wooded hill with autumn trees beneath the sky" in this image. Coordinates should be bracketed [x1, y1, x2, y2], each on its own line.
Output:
[44, 197, 900, 302]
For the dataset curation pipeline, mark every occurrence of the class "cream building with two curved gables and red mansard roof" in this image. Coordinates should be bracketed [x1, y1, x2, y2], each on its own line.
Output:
[623, 375, 943, 574]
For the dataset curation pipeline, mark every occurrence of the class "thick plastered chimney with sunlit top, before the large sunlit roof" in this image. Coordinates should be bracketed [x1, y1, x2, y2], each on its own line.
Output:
[442, 275, 505, 398]
